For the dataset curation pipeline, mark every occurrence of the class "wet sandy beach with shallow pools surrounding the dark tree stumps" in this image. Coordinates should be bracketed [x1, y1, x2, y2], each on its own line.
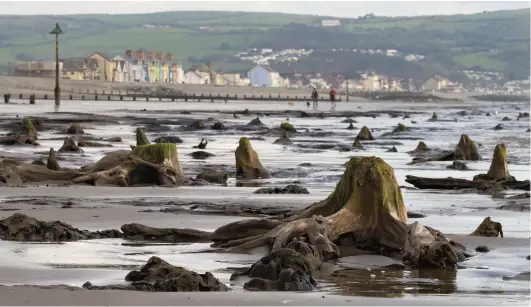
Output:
[0, 98, 531, 306]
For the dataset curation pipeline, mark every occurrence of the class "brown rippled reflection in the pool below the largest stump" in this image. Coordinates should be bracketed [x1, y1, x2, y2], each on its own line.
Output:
[321, 269, 457, 297]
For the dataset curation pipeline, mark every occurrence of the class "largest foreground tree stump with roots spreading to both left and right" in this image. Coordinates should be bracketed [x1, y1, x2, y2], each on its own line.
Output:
[212, 157, 464, 266]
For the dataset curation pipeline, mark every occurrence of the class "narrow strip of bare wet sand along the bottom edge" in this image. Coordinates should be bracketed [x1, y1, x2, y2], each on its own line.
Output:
[0, 287, 527, 306]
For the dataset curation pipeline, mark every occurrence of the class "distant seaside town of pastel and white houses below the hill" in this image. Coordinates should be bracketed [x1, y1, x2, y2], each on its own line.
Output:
[9, 48, 530, 95]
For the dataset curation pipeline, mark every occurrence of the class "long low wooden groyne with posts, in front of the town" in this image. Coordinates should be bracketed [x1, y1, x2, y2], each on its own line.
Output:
[3, 91, 341, 103]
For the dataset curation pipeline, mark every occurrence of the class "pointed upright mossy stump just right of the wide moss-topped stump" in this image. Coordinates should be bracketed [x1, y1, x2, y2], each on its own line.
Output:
[234, 137, 270, 179]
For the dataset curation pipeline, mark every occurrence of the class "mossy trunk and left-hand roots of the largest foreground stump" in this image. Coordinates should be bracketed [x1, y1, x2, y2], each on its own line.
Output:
[218, 157, 408, 256]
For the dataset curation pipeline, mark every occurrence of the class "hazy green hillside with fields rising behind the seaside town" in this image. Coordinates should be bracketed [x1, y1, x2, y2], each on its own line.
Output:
[0, 10, 530, 79]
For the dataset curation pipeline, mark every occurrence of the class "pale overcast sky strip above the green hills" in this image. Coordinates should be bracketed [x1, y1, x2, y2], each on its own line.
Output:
[0, 0, 530, 17]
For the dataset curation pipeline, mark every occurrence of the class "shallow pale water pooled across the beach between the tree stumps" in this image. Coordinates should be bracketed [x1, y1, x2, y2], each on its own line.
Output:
[0, 101, 530, 302]
